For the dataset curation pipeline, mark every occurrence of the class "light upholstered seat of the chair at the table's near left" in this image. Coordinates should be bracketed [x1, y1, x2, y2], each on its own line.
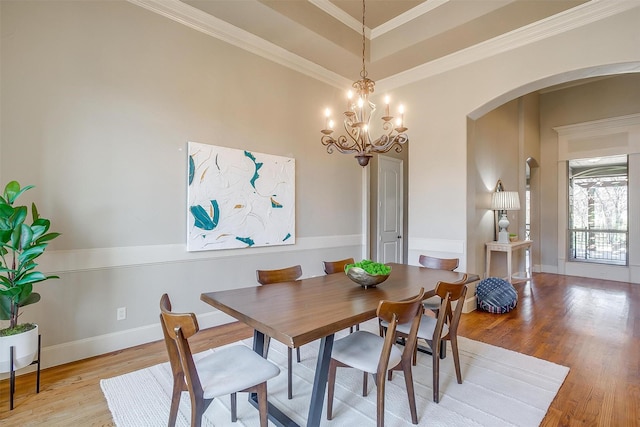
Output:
[195, 345, 280, 399]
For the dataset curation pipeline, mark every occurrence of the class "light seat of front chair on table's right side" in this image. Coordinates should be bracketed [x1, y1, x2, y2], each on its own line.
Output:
[331, 331, 402, 373]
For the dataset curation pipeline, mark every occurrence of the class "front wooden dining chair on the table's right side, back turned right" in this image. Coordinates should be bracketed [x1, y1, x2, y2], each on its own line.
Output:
[327, 288, 424, 427]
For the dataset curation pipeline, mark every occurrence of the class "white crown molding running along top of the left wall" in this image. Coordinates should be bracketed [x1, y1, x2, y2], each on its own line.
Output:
[127, 0, 352, 88]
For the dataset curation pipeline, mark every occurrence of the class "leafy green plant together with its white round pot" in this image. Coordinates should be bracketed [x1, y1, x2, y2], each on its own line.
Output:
[0, 181, 60, 372]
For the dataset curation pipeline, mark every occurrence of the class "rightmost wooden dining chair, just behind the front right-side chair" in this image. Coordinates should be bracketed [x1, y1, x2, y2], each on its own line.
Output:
[387, 282, 467, 403]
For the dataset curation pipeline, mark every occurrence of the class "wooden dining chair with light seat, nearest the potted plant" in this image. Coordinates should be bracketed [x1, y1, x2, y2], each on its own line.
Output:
[160, 294, 280, 427]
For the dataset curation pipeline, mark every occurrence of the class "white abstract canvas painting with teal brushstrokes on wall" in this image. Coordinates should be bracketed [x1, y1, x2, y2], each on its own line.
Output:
[187, 142, 295, 251]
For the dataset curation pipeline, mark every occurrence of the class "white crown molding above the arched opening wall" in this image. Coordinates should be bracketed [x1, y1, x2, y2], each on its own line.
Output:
[376, 0, 640, 91]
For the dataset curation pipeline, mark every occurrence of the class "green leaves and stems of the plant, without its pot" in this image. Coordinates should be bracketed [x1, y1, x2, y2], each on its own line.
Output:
[0, 181, 60, 335]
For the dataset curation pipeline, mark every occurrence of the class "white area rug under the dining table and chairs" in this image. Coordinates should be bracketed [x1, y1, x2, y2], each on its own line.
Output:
[100, 321, 569, 427]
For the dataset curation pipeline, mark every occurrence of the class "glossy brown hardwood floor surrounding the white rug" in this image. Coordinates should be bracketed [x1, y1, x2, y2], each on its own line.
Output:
[0, 273, 640, 427]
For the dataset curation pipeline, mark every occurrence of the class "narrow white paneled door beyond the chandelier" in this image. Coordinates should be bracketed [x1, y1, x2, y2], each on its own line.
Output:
[377, 156, 403, 263]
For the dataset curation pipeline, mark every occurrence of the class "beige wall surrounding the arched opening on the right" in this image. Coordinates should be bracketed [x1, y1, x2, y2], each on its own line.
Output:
[396, 4, 640, 278]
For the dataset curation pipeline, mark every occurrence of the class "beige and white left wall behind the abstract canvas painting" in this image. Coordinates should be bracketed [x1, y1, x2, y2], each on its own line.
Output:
[0, 1, 363, 366]
